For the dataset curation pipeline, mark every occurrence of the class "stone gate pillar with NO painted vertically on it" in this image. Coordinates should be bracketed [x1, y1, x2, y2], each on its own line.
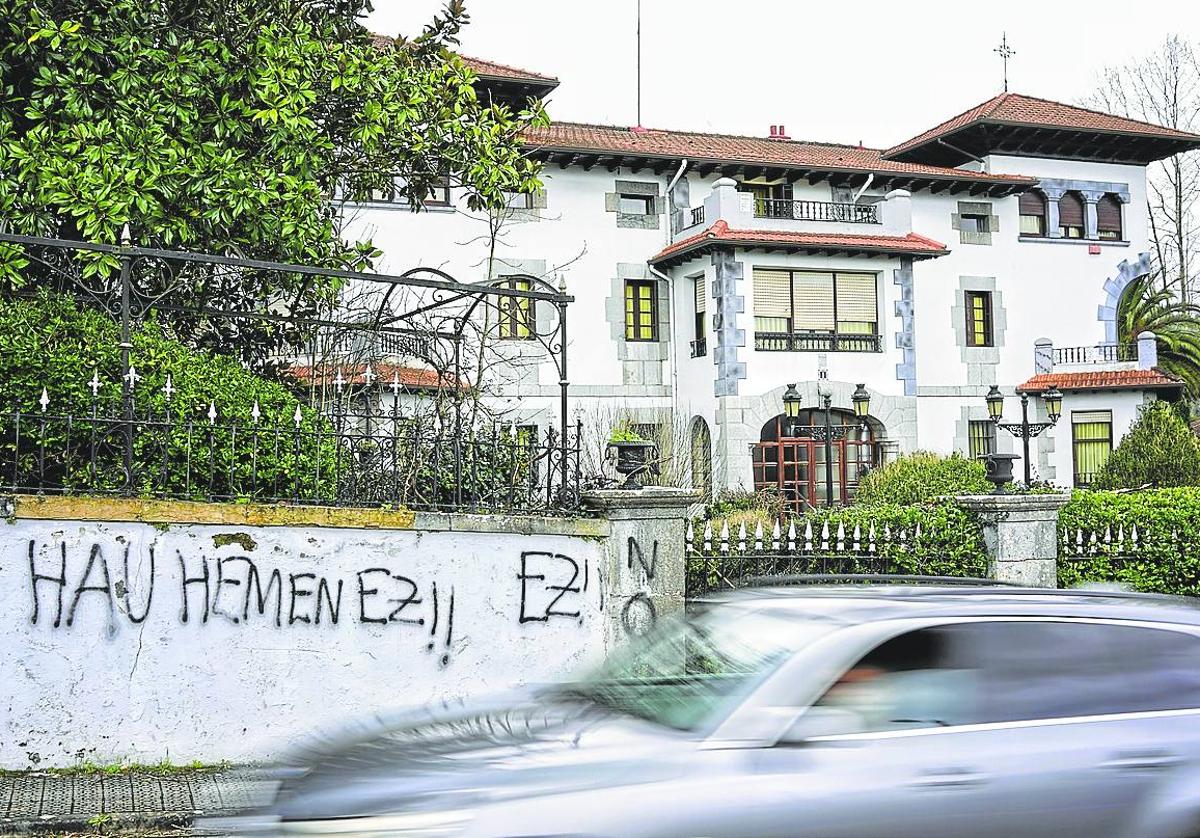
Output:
[583, 486, 700, 650]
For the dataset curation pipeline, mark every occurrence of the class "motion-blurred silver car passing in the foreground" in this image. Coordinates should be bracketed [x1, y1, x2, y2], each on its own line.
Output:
[234, 585, 1200, 838]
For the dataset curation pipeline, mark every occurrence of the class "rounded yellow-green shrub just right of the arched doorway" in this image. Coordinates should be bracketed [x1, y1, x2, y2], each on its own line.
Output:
[854, 451, 992, 505]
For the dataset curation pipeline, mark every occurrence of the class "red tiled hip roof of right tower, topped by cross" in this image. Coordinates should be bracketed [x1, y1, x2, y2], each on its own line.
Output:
[883, 94, 1200, 157]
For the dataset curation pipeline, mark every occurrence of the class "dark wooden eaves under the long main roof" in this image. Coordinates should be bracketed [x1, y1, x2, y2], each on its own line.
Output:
[526, 144, 1038, 198]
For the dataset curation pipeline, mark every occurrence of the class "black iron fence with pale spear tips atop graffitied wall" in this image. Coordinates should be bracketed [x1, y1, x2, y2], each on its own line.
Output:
[0, 379, 581, 514]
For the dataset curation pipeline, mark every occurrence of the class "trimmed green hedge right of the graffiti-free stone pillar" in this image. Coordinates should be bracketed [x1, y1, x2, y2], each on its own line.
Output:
[1058, 487, 1200, 595]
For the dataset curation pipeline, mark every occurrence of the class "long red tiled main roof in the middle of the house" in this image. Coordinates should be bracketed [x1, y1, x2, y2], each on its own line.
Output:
[526, 122, 1037, 185]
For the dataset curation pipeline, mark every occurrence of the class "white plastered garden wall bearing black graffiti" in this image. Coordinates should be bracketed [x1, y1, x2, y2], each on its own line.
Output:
[0, 509, 609, 767]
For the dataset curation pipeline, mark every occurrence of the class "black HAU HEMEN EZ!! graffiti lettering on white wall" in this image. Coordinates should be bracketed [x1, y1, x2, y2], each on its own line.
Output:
[29, 540, 455, 663]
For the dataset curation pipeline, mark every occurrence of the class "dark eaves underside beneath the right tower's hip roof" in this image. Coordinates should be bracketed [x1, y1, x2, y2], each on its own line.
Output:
[883, 119, 1200, 166]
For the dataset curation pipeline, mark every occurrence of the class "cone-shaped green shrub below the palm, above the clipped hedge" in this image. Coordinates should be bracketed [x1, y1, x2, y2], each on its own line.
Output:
[1092, 401, 1200, 489]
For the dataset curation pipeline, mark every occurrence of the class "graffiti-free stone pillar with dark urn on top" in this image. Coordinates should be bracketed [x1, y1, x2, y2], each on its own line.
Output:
[955, 493, 1070, 588]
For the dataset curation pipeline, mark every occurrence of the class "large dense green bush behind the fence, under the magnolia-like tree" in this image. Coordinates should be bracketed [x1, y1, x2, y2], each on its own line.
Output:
[0, 293, 340, 498]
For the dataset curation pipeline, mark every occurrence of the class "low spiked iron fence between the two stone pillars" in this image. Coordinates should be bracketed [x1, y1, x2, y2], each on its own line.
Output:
[685, 519, 986, 598]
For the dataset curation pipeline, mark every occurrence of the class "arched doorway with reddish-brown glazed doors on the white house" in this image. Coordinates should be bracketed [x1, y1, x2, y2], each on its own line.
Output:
[754, 409, 878, 511]
